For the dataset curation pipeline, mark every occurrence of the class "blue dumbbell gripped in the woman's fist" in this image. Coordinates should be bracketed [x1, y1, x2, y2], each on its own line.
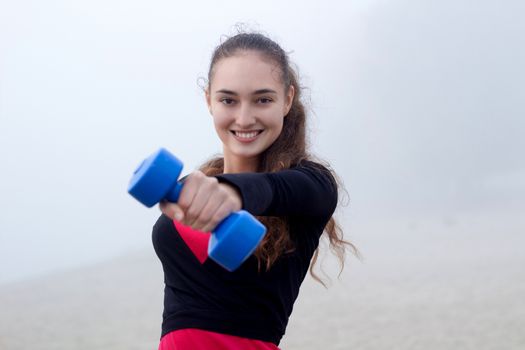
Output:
[128, 148, 266, 271]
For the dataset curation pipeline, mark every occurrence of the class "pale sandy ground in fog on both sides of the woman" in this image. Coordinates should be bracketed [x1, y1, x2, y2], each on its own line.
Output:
[0, 212, 525, 350]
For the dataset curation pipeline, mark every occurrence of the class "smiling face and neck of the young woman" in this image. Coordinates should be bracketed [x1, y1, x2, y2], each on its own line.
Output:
[206, 51, 294, 172]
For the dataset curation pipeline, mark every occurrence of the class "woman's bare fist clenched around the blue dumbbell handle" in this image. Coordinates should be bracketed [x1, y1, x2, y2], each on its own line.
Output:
[159, 171, 242, 232]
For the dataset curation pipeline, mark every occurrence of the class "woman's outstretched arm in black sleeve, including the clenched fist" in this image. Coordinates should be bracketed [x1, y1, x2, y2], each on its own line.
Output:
[159, 162, 337, 232]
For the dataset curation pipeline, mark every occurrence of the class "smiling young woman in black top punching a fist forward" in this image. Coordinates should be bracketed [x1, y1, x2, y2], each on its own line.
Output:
[153, 33, 353, 350]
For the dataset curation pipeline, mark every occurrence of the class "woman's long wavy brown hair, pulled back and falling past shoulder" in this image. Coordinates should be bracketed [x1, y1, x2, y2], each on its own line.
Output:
[200, 32, 358, 285]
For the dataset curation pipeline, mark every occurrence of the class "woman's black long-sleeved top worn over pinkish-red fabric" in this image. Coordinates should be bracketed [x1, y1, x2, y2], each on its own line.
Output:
[153, 161, 337, 345]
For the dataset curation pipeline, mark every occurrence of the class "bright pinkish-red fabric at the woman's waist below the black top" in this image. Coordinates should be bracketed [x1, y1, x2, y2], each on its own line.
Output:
[159, 328, 279, 350]
